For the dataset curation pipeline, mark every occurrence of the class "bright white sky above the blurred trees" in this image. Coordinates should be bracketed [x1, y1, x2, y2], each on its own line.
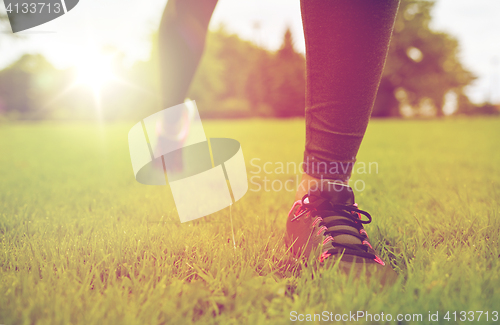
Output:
[0, 0, 500, 103]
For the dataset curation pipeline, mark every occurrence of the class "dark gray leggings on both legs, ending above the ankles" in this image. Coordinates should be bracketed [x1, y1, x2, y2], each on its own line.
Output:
[160, 0, 399, 181]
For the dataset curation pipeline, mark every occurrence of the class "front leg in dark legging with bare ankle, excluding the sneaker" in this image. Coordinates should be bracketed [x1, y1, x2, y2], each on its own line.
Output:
[297, 0, 399, 199]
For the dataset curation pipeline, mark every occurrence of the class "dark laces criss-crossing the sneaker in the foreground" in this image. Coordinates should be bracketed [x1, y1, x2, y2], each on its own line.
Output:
[292, 194, 376, 265]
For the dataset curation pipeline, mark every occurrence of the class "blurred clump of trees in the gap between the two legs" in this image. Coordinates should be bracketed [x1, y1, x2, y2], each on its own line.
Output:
[189, 27, 305, 117]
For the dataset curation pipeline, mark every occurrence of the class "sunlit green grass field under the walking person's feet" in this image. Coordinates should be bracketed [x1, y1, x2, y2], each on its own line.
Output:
[0, 119, 500, 325]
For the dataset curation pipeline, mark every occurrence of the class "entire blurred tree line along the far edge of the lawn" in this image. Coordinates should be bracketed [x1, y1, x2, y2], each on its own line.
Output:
[0, 0, 498, 120]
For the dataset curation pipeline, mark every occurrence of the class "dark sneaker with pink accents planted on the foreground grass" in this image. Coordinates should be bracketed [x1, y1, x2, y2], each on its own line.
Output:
[285, 180, 396, 282]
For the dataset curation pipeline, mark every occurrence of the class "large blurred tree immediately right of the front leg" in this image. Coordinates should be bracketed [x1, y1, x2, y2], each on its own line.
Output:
[372, 0, 474, 117]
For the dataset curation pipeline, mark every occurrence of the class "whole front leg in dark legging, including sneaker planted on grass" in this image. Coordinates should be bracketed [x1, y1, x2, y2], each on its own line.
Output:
[286, 0, 399, 283]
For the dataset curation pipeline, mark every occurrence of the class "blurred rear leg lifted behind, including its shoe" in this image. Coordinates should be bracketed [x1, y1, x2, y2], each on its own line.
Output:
[157, 0, 217, 172]
